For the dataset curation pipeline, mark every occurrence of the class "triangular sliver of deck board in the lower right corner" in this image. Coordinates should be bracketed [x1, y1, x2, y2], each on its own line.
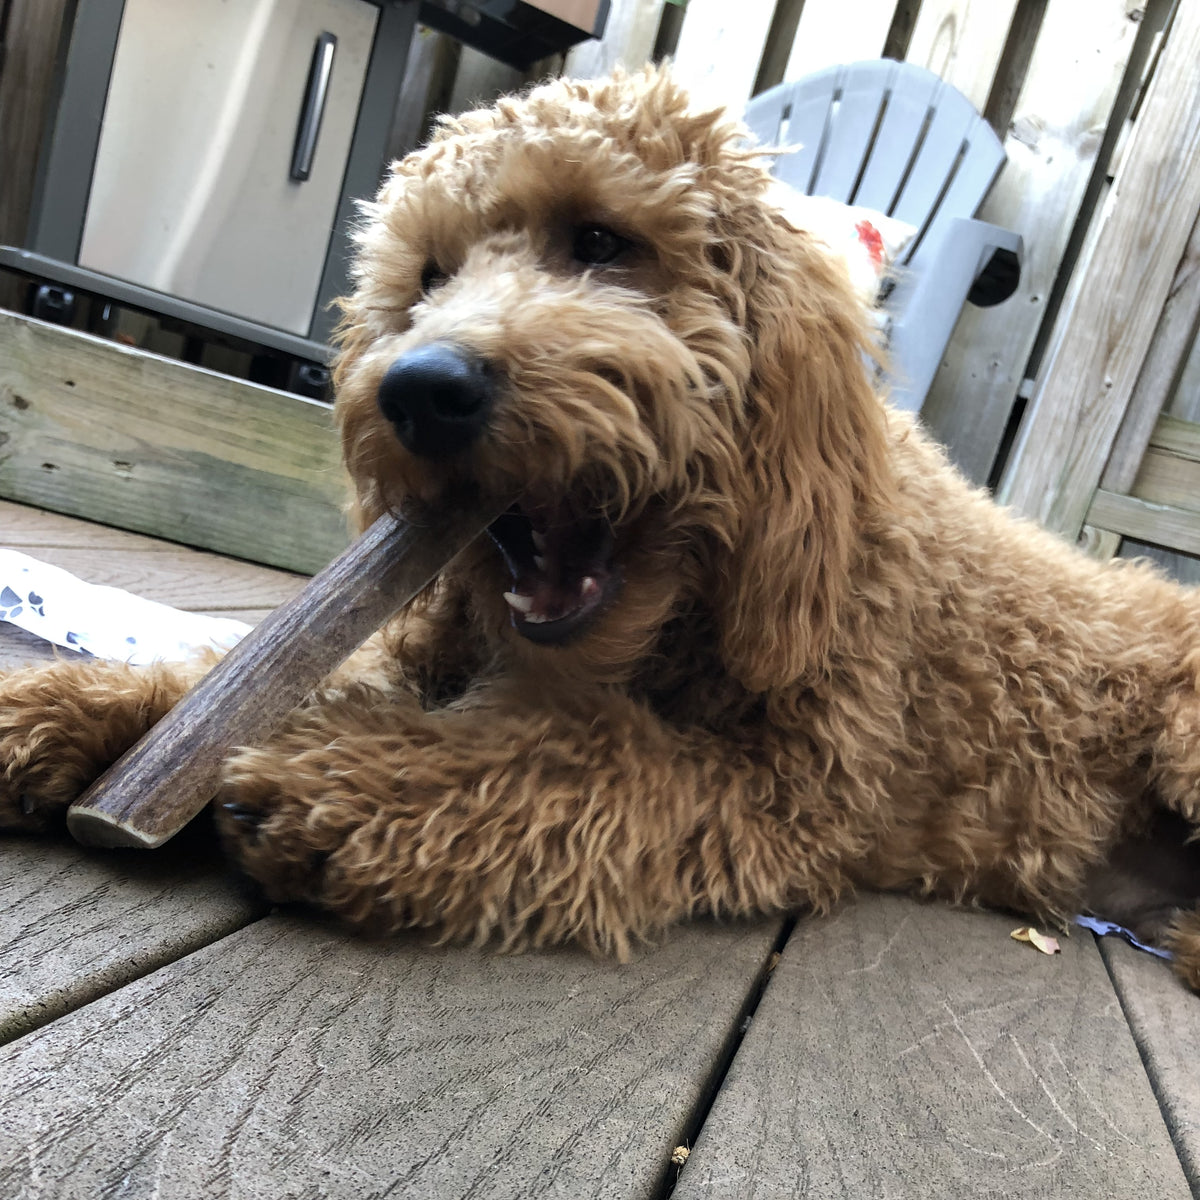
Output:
[1100, 937, 1200, 1195]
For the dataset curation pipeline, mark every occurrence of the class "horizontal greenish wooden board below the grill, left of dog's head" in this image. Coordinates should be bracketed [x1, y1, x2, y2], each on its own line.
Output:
[0, 312, 349, 572]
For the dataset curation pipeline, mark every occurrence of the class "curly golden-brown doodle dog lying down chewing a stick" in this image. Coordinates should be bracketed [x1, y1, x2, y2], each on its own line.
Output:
[0, 63, 1200, 988]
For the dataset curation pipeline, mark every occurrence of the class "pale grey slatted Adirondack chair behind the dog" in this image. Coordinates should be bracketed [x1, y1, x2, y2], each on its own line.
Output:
[745, 59, 1022, 412]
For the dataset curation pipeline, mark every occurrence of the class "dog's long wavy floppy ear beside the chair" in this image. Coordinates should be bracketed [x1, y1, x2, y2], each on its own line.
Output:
[715, 204, 888, 691]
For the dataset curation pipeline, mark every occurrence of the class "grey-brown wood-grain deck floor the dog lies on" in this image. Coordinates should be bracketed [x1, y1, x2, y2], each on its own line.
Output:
[0, 502, 1200, 1200]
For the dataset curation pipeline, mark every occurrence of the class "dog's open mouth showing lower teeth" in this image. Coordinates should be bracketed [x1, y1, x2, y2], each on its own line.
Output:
[487, 500, 620, 646]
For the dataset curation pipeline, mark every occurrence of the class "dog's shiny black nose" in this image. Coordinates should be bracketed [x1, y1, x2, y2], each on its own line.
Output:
[378, 342, 493, 458]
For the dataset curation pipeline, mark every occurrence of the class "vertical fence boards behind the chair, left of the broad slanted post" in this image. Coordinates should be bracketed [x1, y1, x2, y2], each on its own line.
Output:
[419, 0, 1171, 482]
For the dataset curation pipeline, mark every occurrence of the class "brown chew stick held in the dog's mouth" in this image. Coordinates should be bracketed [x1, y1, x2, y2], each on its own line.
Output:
[67, 502, 508, 850]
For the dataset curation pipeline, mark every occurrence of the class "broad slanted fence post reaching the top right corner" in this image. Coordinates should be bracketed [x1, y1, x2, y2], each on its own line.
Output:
[1001, 4, 1200, 538]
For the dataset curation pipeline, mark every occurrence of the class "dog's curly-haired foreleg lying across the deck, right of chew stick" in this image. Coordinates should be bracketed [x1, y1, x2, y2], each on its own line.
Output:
[217, 691, 844, 954]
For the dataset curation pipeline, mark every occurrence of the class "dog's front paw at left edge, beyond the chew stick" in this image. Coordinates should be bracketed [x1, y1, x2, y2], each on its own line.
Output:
[0, 659, 199, 832]
